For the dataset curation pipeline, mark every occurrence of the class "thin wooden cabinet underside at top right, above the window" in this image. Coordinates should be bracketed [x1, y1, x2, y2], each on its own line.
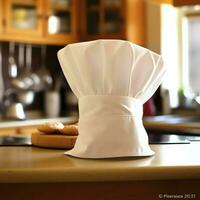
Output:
[147, 0, 200, 6]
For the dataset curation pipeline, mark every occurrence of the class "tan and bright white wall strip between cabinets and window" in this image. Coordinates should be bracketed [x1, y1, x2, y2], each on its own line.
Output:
[146, 3, 182, 107]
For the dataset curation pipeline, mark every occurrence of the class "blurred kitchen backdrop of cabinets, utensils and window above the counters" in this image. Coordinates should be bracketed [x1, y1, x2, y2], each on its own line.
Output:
[0, 0, 200, 121]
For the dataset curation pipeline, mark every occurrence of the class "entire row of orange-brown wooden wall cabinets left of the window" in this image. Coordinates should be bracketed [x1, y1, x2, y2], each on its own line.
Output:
[0, 0, 145, 45]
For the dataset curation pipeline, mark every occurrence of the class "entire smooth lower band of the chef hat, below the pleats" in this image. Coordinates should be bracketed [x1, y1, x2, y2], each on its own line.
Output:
[68, 95, 154, 158]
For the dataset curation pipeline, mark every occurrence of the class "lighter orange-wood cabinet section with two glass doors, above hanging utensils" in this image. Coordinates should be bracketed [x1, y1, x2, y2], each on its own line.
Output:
[0, 0, 77, 45]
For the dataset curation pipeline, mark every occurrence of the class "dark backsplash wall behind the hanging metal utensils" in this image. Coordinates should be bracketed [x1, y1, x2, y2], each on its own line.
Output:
[0, 42, 77, 116]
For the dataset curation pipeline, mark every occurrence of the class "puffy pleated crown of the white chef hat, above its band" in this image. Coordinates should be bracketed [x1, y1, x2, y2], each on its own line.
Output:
[58, 40, 166, 103]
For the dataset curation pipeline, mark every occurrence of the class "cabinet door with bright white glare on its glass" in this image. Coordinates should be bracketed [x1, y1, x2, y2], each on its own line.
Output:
[44, 0, 79, 44]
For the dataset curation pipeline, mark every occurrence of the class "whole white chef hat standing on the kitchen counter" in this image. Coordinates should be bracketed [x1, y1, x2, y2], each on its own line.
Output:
[58, 40, 166, 158]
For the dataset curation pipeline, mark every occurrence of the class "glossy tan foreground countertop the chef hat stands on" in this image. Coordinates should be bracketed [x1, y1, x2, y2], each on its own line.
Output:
[0, 142, 200, 183]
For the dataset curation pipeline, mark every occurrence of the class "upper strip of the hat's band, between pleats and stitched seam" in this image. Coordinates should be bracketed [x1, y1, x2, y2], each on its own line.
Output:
[79, 95, 143, 119]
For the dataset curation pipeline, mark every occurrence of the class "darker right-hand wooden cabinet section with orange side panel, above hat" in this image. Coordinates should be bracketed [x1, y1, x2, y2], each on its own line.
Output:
[81, 0, 145, 45]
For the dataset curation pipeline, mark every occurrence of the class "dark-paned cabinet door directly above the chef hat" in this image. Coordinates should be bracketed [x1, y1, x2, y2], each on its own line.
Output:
[82, 0, 126, 39]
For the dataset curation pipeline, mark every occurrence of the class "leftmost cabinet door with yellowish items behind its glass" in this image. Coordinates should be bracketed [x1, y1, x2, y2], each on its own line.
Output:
[4, 0, 43, 38]
